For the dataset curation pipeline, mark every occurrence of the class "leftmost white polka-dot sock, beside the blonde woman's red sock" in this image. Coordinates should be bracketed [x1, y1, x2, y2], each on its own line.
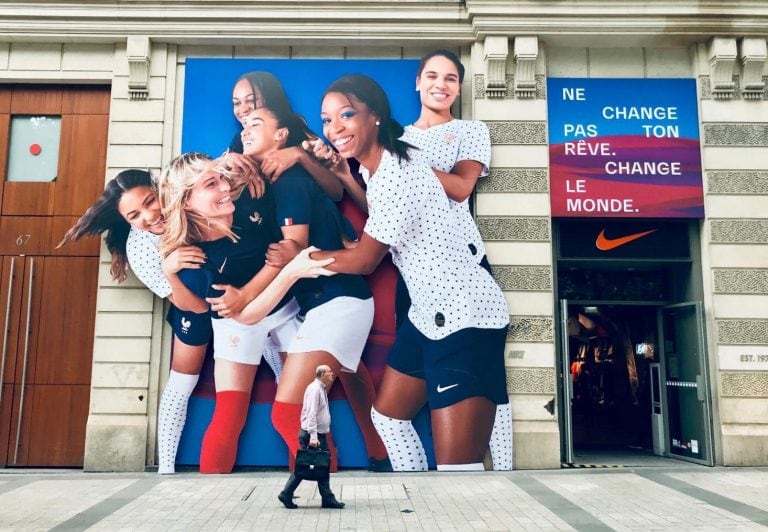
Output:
[157, 370, 200, 475]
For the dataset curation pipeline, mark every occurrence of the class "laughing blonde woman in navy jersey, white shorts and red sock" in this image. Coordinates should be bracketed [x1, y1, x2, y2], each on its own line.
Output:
[159, 153, 332, 473]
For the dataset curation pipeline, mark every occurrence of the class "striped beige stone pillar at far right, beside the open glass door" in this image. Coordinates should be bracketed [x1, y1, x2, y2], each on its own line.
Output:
[695, 44, 768, 466]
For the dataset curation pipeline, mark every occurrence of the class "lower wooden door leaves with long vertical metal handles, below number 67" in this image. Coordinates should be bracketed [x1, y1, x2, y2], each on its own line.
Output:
[0, 249, 99, 467]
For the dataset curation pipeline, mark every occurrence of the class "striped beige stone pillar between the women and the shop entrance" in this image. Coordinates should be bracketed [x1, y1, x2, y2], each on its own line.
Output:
[464, 40, 560, 469]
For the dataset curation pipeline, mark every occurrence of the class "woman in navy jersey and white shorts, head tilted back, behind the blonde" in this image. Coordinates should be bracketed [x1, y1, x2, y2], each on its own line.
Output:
[237, 72, 386, 470]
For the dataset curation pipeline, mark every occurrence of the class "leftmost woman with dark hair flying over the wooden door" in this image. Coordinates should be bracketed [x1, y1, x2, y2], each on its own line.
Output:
[59, 169, 211, 474]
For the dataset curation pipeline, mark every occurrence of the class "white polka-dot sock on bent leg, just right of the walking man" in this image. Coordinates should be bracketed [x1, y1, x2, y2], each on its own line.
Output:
[371, 408, 428, 471]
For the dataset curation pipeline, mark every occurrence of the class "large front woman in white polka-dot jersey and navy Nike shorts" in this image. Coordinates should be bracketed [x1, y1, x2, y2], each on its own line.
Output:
[312, 74, 509, 470]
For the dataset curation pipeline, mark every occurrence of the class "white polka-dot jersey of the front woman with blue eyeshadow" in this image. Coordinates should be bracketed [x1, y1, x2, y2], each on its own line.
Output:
[361, 151, 509, 340]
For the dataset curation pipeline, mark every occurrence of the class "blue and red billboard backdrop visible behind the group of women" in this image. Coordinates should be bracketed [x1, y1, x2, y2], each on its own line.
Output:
[177, 58, 426, 467]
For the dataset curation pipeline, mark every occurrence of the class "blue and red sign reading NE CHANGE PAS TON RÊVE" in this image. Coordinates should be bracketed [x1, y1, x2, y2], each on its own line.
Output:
[547, 78, 704, 218]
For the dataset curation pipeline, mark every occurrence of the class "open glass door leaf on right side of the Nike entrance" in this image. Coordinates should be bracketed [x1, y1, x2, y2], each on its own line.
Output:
[659, 302, 713, 465]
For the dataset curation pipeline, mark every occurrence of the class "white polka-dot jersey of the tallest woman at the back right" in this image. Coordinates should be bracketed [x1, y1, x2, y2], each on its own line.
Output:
[400, 120, 491, 262]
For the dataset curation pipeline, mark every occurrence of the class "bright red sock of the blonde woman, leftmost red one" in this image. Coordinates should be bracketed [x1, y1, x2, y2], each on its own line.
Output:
[200, 390, 251, 473]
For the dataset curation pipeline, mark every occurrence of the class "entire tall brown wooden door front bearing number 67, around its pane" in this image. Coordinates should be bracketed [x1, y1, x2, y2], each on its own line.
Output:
[0, 86, 110, 467]
